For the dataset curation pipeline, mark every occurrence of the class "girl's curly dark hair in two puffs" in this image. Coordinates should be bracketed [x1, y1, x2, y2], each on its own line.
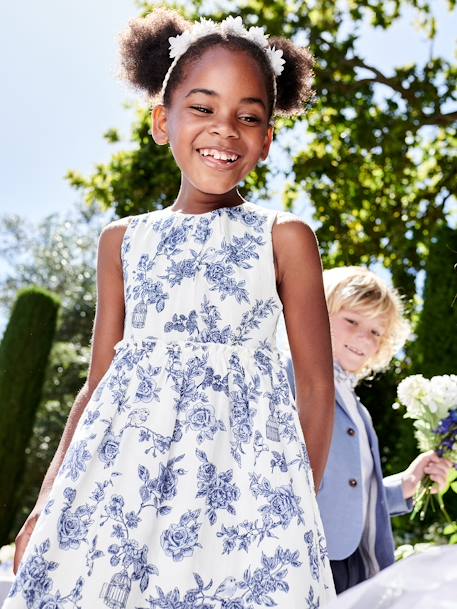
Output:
[121, 8, 314, 116]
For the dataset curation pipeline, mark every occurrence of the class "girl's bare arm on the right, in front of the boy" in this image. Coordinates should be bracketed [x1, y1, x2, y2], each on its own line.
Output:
[273, 214, 335, 489]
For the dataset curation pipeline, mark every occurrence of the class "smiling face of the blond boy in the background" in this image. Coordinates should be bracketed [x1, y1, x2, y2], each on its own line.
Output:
[330, 309, 387, 373]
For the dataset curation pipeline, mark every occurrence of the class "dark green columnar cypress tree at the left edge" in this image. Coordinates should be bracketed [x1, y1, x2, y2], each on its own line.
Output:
[0, 288, 60, 545]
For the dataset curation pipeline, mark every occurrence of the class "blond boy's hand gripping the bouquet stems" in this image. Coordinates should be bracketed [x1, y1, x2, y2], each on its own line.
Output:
[402, 450, 452, 499]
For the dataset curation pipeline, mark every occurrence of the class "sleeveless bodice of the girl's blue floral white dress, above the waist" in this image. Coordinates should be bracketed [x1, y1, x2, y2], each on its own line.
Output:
[122, 203, 282, 347]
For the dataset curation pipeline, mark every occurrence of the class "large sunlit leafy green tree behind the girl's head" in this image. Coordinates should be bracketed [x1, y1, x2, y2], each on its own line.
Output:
[68, 0, 457, 298]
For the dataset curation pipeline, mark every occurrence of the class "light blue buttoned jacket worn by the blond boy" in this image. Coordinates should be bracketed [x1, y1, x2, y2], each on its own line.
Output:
[287, 360, 412, 569]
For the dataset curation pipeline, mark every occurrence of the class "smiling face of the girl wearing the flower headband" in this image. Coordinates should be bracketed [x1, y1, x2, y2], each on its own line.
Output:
[153, 46, 272, 202]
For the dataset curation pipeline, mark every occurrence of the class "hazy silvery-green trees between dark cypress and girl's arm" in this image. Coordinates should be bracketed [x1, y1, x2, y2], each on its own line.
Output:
[0, 205, 105, 538]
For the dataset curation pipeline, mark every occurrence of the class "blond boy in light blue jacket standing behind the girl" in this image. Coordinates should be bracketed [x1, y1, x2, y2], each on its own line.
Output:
[288, 267, 451, 593]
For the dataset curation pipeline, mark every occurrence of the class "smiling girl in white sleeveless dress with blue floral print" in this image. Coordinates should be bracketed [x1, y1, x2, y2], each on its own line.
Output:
[5, 9, 334, 609]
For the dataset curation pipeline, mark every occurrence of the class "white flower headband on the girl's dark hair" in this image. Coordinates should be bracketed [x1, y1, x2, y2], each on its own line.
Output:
[161, 15, 286, 99]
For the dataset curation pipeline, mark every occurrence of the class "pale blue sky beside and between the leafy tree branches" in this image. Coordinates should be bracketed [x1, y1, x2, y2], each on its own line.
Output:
[0, 0, 457, 220]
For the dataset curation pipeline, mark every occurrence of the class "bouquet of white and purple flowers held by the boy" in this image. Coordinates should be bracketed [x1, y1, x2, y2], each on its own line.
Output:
[397, 374, 457, 520]
